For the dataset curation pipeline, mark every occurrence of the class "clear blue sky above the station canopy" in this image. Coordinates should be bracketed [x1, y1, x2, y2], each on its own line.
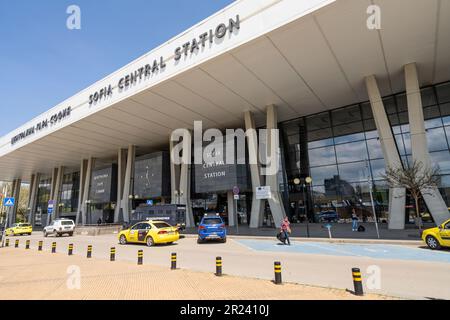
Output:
[0, 0, 233, 136]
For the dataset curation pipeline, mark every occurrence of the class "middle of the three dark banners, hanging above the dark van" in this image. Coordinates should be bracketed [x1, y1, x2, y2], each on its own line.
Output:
[134, 151, 170, 199]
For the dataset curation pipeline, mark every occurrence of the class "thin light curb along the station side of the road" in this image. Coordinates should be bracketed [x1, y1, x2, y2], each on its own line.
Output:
[182, 234, 424, 246]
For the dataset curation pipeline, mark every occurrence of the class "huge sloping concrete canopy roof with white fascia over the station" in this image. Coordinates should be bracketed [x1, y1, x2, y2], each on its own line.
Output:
[0, 0, 450, 181]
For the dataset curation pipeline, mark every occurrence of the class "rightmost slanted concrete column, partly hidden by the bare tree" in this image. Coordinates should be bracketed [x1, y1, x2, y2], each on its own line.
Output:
[405, 63, 450, 225]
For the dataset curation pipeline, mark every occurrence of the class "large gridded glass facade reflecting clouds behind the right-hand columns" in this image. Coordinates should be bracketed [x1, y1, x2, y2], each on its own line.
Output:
[280, 83, 450, 221]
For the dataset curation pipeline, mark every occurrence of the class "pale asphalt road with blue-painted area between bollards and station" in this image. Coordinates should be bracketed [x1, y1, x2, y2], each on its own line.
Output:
[4, 232, 450, 299]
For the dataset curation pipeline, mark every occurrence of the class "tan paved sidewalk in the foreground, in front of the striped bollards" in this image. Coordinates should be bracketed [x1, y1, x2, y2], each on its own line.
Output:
[0, 248, 392, 300]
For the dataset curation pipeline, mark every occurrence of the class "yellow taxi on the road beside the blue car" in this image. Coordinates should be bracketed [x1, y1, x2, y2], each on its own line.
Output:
[118, 220, 180, 247]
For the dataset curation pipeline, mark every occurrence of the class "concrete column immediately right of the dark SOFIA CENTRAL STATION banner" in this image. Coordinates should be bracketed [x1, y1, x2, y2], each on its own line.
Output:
[244, 111, 264, 228]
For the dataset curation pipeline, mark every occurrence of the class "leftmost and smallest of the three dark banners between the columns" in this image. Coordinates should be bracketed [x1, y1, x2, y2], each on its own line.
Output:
[89, 164, 117, 203]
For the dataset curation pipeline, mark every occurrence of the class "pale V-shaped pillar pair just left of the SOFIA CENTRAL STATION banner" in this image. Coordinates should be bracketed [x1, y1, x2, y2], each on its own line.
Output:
[169, 130, 195, 227]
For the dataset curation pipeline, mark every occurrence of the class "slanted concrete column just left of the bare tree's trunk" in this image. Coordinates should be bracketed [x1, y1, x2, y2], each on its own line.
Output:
[366, 75, 406, 230]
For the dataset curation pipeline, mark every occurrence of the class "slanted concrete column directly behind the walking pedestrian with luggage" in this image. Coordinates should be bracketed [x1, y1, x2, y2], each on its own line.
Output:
[266, 105, 286, 228]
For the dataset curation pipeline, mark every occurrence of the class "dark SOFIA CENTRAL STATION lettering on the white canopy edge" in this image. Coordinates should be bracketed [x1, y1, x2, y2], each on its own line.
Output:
[89, 15, 241, 105]
